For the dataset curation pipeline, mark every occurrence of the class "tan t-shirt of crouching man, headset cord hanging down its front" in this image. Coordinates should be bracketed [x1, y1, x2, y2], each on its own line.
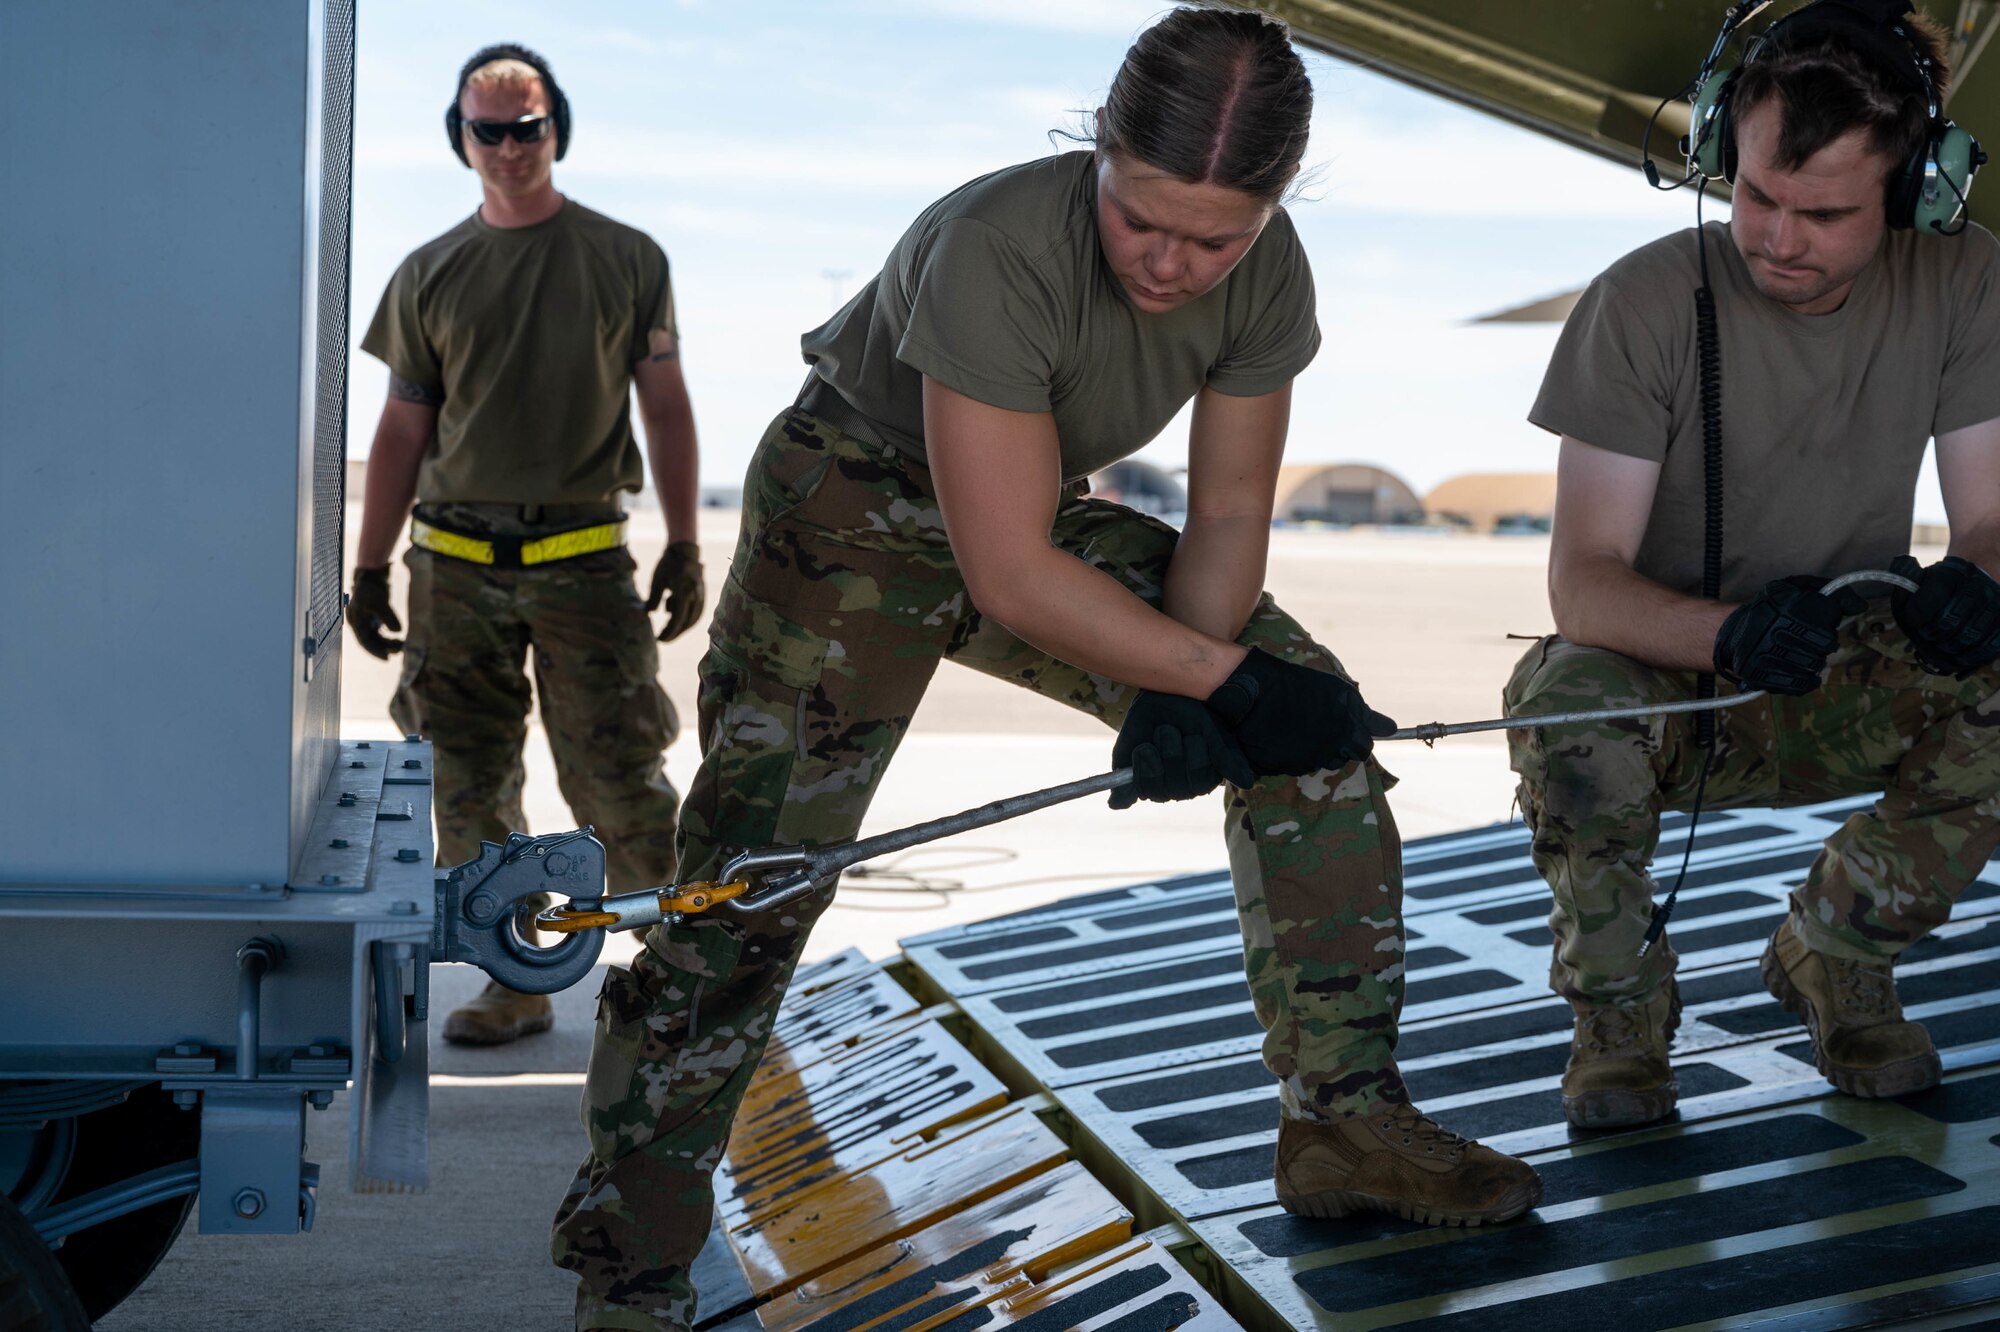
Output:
[1528, 222, 2000, 600]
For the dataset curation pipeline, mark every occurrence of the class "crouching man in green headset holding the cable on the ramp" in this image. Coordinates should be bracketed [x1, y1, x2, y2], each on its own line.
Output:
[1506, 0, 2000, 1126]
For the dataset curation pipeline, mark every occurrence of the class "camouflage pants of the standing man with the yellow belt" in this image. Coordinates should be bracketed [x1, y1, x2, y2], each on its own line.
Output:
[390, 504, 680, 892]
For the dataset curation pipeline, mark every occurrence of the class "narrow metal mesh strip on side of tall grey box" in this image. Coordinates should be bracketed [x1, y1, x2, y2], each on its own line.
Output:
[306, 0, 354, 668]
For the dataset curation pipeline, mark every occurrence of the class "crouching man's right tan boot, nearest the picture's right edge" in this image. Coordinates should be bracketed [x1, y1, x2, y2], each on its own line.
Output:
[1764, 918, 1944, 1096]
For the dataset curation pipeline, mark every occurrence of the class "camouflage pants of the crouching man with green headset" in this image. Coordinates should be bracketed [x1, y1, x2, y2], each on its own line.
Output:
[1506, 616, 2000, 1002]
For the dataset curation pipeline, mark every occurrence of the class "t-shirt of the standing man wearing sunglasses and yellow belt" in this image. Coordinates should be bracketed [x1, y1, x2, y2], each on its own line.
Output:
[362, 200, 674, 504]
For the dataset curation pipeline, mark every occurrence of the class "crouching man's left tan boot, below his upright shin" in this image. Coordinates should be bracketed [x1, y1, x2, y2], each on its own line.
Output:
[1562, 980, 1680, 1128]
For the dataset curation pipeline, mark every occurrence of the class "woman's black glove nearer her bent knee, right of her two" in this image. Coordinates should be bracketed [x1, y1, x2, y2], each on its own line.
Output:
[1208, 648, 1396, 776]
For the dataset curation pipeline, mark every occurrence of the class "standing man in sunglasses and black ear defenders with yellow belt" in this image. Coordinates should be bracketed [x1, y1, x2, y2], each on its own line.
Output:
[348, 46, 704, 1044]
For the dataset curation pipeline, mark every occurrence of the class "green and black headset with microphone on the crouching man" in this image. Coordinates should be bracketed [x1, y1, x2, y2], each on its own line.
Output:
[1682, 0, 1986, 236]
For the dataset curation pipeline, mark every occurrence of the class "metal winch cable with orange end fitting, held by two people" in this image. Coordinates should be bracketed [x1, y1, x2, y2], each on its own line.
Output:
[534, 570, 1916, 934]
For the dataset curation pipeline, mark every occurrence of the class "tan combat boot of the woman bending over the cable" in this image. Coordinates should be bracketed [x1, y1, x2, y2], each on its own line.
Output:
[1278, 1106, 1542, 1226]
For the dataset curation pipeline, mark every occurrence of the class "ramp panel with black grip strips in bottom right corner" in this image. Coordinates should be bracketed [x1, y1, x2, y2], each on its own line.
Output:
[1194, 1066, 2000, 1328]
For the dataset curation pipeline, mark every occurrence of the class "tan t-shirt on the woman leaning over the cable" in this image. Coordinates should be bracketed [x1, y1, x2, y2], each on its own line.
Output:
[802, 152, 1320, 480]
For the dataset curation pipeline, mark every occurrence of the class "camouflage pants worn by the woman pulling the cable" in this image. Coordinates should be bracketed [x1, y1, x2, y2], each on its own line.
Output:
[552, 410, 1404, 1328]
